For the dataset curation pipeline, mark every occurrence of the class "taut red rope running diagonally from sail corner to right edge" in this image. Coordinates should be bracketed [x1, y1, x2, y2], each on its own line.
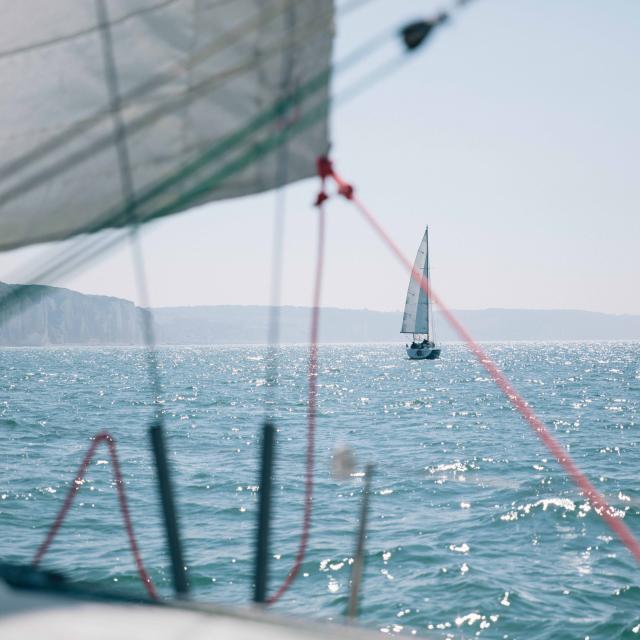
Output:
[320, 158, 640, 562]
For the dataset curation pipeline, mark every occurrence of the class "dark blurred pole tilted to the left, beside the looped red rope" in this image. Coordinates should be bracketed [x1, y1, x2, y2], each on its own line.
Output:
[149, 422, 189, 598]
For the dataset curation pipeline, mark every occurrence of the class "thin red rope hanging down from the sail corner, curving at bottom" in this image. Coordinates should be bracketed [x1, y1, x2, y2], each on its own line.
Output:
[267, 170, 327, 604]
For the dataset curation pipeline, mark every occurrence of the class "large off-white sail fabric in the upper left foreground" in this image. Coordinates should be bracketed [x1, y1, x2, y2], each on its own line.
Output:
[0, 0, 334, 250]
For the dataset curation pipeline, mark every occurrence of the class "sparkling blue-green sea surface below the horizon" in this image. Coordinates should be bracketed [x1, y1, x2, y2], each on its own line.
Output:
[0, 342, 640, 640]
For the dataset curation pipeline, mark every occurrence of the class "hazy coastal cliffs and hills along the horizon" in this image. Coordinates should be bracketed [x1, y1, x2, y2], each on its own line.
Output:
[0, 283, 640, 346]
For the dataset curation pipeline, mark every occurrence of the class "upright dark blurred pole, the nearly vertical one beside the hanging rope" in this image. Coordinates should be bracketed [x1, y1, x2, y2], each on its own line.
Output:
[253, 422, 275, 602]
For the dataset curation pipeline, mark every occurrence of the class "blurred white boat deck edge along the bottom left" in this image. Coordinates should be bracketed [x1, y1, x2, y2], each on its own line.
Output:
[0, 579, 390, 640]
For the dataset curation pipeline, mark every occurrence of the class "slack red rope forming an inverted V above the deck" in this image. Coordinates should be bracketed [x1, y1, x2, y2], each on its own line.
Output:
[32, 431, 158, 600]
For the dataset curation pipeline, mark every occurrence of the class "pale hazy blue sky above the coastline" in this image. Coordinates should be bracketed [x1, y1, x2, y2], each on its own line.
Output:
[0, 0, 640, 313]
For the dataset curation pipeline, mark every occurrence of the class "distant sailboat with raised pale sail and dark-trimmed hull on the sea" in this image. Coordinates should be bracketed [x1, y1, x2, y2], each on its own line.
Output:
[400, 227, 440, 360]
